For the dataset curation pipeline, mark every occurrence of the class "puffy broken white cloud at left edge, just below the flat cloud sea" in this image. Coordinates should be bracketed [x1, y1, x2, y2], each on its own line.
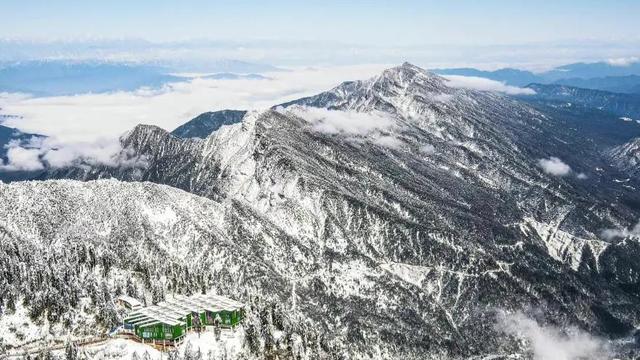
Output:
[0, 138, 147, 171]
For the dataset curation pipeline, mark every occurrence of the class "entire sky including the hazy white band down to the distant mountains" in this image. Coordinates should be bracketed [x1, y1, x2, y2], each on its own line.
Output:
[0, 0, 640, 68]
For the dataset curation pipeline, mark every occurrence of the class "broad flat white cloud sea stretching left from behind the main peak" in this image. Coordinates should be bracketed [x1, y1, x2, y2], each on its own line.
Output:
[0, 65, 388, 142]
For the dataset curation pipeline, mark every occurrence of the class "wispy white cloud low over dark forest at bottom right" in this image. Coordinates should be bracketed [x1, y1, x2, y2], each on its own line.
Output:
[496, 312, 609, 360]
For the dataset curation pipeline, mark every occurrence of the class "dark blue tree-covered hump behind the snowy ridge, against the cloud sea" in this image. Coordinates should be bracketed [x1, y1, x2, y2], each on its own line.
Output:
[171, 110, 247, 139]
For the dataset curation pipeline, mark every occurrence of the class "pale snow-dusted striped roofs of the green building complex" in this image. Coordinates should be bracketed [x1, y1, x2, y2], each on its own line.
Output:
[124, 295, 245, 326]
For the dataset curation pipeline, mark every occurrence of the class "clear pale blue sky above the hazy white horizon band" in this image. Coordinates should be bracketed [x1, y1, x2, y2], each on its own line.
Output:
[5, 0, 640, 46]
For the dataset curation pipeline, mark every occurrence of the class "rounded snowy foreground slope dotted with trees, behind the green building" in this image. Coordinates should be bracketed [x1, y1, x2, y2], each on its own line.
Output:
[0, 180, 336, 353]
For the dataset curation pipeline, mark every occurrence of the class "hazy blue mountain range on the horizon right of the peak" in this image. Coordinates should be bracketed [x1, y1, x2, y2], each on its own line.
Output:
[433, 62, 640, 93]
